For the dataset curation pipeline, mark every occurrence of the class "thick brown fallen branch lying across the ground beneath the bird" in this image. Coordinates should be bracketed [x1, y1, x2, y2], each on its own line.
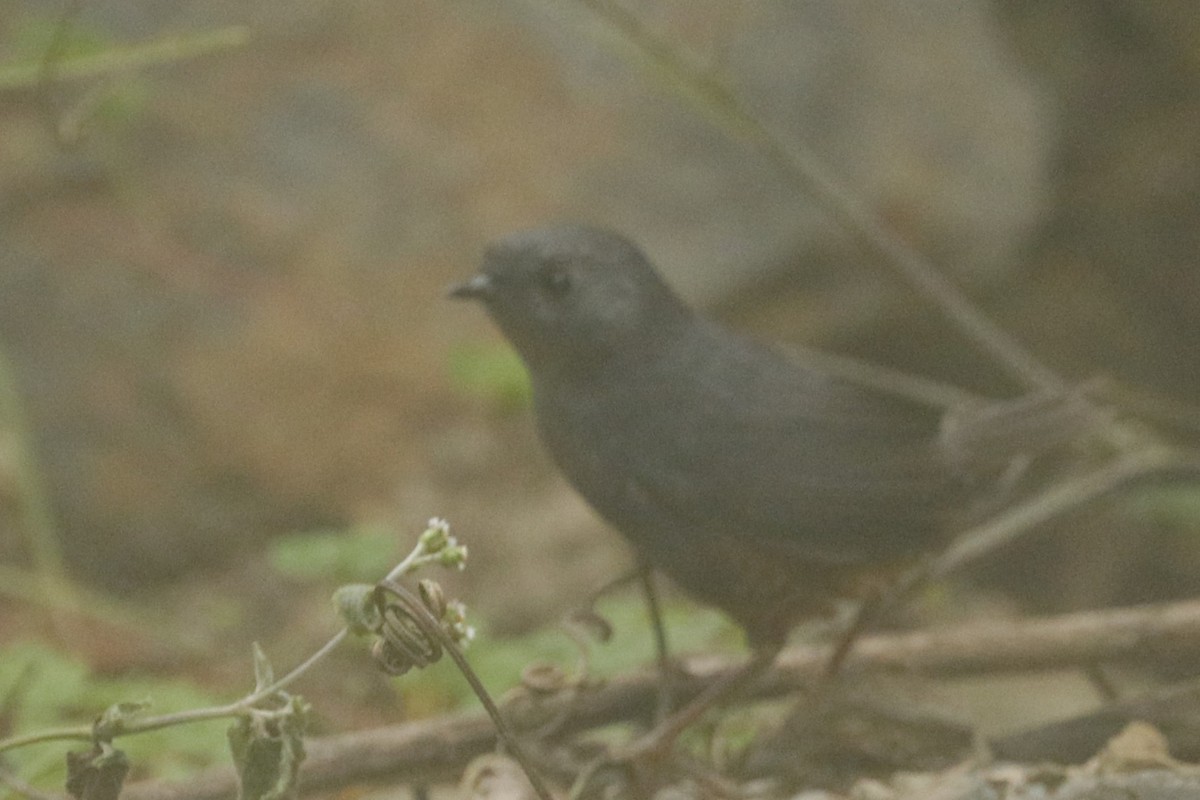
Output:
[114, 601, 1200, 800]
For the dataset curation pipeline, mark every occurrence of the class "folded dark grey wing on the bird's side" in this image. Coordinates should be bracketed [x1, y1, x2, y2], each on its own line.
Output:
[626, 331, 953, 564]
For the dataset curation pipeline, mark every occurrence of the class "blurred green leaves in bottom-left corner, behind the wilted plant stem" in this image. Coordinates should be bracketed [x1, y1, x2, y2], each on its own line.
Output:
[0, 642, 227, 787]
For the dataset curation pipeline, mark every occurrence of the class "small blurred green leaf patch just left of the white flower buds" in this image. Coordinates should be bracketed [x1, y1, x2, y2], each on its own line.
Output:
[270, 525, 403, 583]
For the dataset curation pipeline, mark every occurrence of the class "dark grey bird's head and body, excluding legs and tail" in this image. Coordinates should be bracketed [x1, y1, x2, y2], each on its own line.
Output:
[451, 225, 968, 654]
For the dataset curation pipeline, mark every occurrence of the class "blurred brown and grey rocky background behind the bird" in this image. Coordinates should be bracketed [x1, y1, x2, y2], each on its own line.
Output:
[0, 0, 1200, 782]
